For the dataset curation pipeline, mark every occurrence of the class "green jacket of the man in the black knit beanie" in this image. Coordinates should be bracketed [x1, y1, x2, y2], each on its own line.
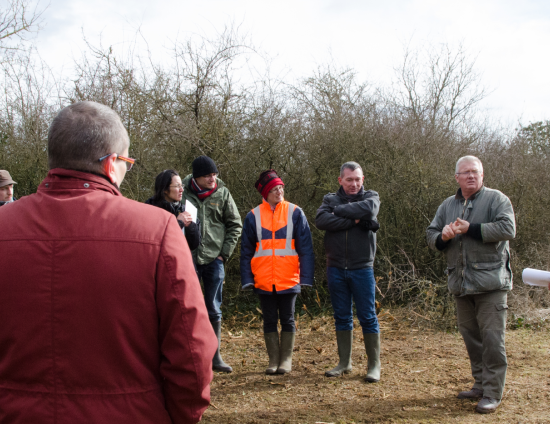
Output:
[182, 175, 243, 265]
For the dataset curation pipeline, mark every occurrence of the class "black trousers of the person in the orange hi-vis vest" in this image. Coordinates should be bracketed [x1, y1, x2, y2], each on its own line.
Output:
[258, 292, 298, 333]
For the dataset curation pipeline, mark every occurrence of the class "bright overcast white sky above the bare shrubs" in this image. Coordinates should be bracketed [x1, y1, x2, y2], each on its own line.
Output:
[37, 0, 550, 124]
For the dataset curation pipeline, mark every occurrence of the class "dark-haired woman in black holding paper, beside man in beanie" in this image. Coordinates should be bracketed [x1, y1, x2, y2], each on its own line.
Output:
[145, 169, 201, 250]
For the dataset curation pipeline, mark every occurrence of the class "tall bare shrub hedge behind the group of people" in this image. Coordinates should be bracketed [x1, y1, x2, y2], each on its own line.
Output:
[0, 27, 550, 328]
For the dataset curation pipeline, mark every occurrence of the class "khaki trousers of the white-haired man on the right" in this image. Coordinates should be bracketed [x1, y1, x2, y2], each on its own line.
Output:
[455, 291, 508, 400]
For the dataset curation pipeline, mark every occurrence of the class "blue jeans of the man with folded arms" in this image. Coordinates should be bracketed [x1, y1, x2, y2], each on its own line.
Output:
[327, 266, 380, 334]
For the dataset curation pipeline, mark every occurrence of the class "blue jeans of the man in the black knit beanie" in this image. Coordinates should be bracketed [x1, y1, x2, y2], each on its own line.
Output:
[197, 258, 225, 322]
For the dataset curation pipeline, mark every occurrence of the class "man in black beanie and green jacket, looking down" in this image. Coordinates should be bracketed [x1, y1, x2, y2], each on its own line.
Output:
[182, 156, 242, 372]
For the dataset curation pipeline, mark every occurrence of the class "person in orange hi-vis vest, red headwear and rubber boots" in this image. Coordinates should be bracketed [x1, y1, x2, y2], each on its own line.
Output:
[241, 169, 315, 374]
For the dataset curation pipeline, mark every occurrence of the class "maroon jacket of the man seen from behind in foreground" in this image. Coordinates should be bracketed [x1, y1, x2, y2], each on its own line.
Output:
[0, 169, 217, 424]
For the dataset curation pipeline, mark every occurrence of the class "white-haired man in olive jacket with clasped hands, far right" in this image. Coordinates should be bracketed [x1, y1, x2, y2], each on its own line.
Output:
[427, 156, 516, 414]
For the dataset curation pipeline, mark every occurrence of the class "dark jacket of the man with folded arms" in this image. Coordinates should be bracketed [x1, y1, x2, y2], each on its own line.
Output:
[315, 187, 380, 269]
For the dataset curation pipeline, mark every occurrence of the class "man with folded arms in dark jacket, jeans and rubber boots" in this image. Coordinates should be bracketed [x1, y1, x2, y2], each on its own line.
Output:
[315, 162, 381, 383]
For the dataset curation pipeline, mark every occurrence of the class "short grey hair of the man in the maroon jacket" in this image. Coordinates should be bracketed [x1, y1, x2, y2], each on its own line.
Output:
[48, 101, 129, 174]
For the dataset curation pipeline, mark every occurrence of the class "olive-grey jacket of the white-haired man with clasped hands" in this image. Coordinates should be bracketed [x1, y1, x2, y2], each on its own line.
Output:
[427, 187, 516, 296]
